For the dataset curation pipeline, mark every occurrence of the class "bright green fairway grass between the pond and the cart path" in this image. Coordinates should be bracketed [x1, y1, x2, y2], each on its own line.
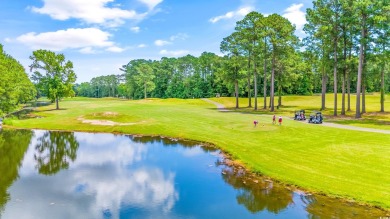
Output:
[7, 95, 390, 210]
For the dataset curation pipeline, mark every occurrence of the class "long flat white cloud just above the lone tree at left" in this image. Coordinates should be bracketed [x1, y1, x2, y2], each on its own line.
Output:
[16, 28, 115, 52]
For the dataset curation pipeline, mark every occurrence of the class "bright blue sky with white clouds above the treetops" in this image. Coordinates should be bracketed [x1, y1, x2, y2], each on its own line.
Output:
[0, 0, 312, 83]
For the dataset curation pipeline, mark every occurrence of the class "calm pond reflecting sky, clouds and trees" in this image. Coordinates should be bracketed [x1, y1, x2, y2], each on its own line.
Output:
[0, 130, 386, 219]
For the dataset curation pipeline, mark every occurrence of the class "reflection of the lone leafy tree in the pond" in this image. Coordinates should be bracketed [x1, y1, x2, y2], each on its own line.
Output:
[34, 132, 79, 175]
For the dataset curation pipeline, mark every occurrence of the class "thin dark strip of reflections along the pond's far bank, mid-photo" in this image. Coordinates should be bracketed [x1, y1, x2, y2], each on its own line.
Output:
[129, 136, 218, 152]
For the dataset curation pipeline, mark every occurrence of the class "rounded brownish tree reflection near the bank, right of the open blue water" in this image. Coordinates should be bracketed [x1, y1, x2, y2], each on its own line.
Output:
[219, 164, 293, 214]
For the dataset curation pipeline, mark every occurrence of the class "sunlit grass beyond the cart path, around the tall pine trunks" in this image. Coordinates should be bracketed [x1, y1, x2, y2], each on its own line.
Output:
[211, 93, 390, 130]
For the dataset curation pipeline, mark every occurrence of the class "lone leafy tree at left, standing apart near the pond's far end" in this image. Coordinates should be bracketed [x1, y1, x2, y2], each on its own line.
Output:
[30, 50, 76, 109]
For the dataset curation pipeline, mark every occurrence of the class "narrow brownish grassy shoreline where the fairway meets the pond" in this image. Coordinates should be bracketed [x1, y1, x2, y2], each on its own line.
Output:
[3, 125, 390, 217]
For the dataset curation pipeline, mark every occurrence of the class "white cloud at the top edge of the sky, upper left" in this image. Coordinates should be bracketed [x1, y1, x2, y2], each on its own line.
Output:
[31, 0, 146, 27]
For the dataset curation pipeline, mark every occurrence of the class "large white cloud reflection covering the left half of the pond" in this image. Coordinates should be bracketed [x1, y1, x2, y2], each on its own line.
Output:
[1, 132, 179, 218]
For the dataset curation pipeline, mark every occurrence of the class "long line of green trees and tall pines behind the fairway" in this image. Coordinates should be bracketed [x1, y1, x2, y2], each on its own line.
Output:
[76, 0, 390, 118]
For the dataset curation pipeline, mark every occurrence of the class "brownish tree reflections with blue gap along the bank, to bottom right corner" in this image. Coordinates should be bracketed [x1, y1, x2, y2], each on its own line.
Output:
[216, 159, 388, 219]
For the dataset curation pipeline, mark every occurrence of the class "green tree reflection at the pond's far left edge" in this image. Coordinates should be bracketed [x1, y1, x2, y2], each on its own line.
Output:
[0, 130, 33, 212]
